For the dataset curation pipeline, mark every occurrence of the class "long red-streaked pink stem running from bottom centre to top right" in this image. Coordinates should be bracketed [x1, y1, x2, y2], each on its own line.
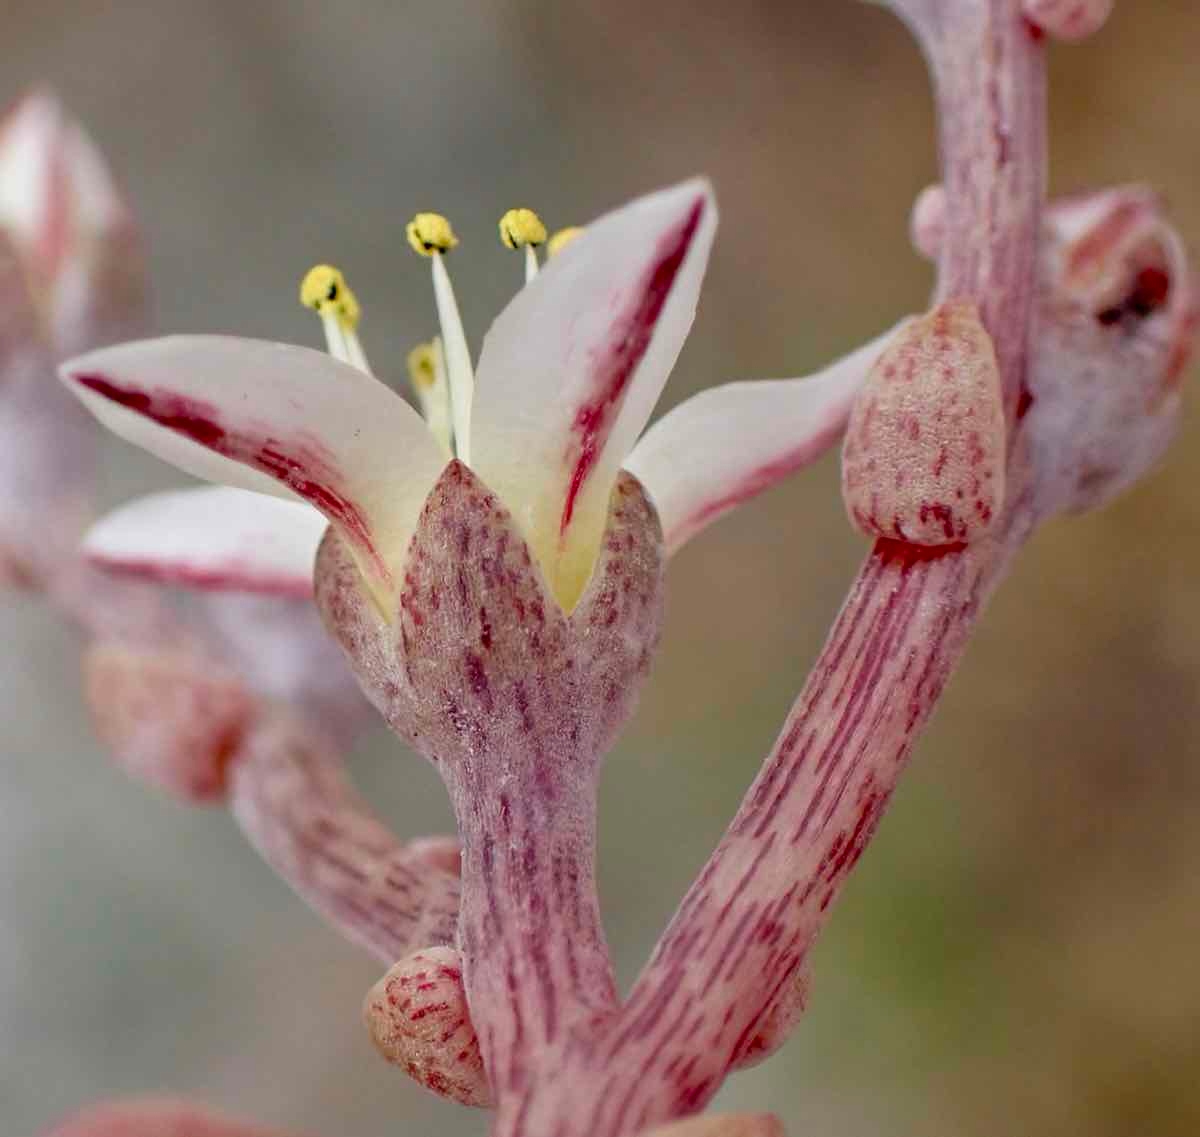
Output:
[493, 0, 1045, 1137]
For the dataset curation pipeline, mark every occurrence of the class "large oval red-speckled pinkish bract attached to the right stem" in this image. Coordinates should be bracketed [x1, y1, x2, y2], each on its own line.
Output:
[842, 301, 1006, 546]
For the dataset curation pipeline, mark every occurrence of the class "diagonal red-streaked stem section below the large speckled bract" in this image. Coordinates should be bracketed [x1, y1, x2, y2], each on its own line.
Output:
[511, 489, 1032, 1137]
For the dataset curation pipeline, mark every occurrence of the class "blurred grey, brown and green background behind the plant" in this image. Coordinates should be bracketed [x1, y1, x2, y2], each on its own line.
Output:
[0, 0, 1200, 1137]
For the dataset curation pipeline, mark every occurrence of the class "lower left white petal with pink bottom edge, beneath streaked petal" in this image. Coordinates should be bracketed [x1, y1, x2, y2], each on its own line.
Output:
[83, 486, 328, 596]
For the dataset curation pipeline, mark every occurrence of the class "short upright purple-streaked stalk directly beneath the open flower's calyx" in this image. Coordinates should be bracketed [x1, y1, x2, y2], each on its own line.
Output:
[449, 756, 617, 1108]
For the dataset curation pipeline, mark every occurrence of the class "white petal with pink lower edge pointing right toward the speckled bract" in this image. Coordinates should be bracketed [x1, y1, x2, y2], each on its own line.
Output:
[625, 325, 901, 552]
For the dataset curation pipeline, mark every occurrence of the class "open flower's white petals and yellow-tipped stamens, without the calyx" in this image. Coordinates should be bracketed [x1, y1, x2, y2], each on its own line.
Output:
[62, 181, 877, 613]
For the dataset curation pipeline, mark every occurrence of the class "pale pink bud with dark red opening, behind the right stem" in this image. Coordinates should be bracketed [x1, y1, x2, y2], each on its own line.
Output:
[1022, 186, 1198, 513]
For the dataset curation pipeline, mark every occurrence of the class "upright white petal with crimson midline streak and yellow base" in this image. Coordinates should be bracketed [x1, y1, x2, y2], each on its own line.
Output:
[472, 181, 716, 607]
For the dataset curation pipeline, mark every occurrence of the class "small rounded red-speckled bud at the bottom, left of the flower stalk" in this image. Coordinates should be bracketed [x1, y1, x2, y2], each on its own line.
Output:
[362, 948, 491, 1106]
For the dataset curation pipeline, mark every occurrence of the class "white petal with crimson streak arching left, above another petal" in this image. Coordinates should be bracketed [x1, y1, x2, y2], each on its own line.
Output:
[61, 336, 445, 601]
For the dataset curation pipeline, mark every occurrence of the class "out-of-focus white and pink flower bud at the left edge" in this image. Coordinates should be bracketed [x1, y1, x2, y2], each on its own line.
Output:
[0, 91, 145, 585]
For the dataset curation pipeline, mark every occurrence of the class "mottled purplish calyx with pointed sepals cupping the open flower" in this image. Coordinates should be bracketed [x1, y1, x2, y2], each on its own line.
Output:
[316, 462, 664, 764]
